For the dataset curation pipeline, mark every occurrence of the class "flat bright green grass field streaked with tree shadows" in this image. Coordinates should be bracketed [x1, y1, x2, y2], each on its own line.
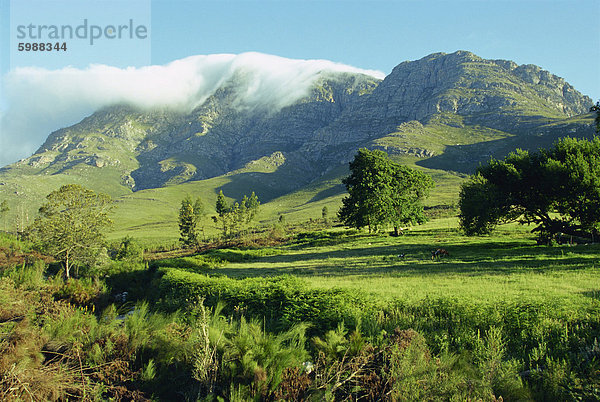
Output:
[191, 219, 600, 312]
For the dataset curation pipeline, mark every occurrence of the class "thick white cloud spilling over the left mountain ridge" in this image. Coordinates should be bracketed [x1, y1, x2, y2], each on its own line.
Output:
[0, 53, 384, 166]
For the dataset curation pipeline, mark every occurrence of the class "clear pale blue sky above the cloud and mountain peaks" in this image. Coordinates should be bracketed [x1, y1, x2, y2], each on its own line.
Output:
[0, 0, 600, 165]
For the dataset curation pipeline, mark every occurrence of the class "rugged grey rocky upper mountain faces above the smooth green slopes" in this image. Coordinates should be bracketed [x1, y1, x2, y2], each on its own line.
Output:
[0, 51, 592, 196]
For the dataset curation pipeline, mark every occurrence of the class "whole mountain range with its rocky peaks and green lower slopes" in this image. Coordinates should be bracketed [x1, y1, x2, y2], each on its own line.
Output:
[0, 51, 593, 239]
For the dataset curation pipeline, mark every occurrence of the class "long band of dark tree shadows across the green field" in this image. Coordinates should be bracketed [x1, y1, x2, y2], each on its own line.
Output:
[209, 241, 594, 278]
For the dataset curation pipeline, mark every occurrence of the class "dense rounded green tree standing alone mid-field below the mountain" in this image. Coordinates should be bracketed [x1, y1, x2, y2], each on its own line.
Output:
[338, 148, 434, 233]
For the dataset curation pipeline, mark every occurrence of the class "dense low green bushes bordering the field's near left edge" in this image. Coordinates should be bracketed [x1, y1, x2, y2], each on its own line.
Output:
[158, 268, 378, 333]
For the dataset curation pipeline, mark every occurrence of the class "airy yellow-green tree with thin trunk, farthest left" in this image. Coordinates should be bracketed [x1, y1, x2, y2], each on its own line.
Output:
[30, 184, 112, 278]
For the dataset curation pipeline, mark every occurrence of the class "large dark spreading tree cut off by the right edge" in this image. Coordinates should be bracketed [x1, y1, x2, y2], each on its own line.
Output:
[459, 138, 600, 243]
